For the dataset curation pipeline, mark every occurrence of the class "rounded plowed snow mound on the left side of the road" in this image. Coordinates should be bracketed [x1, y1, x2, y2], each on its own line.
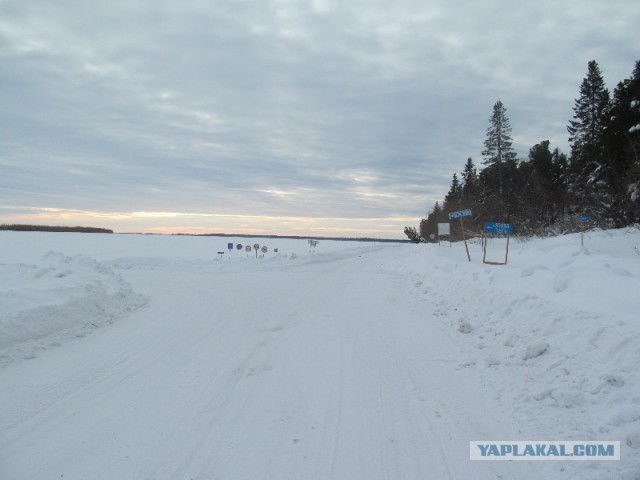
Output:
[0, 252, 145, 365]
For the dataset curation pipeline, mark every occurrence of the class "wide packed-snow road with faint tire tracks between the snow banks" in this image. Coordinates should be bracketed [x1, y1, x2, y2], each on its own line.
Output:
[0, 234, 638, 480]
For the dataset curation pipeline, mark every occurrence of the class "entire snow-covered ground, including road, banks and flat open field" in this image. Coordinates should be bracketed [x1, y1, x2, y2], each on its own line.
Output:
[0, 229, 640, 480]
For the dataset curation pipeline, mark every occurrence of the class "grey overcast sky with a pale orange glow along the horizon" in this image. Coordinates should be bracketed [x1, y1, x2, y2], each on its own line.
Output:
[0, 0, 640, 238]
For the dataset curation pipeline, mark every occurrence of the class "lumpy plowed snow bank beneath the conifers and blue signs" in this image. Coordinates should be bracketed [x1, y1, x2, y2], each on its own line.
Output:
[407, 228, 640, 480]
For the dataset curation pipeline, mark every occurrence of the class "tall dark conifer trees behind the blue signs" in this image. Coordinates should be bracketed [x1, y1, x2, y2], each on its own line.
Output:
[404, 60, 640, 242]
